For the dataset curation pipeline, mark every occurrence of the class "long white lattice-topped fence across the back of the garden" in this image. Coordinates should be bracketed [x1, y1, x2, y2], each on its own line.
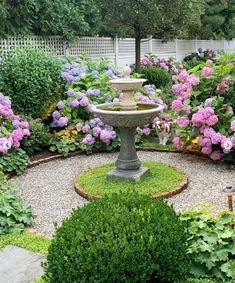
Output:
[0, 36, 235, 66]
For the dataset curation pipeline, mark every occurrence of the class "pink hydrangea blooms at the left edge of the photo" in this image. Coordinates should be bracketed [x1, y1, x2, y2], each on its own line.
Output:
[0, 93, 30, 154]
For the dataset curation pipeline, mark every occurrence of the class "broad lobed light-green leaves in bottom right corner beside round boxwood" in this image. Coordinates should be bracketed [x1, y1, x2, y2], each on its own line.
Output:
[181, 211, 235, 282]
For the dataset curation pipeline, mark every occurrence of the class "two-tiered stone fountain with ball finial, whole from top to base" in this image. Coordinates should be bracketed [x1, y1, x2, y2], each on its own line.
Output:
[92, 66, 163, 181]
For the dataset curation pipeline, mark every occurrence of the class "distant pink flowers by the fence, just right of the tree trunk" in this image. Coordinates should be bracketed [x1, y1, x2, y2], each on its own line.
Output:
[141, 54, 183, 74]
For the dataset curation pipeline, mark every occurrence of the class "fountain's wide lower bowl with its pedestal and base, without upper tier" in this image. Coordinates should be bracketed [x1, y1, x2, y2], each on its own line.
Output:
[92, 102, 163, 181]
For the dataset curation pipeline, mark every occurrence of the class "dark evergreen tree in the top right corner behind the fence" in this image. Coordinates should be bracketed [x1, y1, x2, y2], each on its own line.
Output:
[197, 0, 235, 39]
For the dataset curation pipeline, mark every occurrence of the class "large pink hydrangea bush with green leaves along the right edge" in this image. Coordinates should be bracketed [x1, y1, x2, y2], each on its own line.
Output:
[171, 54, 235, 162]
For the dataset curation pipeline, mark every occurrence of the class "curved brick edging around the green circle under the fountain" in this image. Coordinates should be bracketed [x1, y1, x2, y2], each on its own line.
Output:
[74, 165, 189, 200]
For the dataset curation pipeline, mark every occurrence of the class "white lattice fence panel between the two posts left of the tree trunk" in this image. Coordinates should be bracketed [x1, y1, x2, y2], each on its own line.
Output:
[69, 37, 115, 56]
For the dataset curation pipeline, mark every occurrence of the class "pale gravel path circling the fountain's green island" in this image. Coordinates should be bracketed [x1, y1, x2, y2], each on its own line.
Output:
[16, 151, 235, 235]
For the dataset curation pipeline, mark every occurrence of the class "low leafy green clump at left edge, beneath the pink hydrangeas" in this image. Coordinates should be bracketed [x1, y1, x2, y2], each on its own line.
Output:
[0, 148, 29, 175]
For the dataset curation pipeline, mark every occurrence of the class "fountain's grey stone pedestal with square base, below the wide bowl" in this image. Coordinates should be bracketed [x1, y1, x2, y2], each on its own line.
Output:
[107, 128, 149, 181]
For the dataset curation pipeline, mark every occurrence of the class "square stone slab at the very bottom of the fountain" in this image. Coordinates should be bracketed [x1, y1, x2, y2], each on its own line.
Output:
[107, 167, 149, 181]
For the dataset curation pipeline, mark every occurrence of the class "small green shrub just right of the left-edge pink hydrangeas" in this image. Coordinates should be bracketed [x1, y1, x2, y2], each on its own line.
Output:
[21, 118, 51, 155]
